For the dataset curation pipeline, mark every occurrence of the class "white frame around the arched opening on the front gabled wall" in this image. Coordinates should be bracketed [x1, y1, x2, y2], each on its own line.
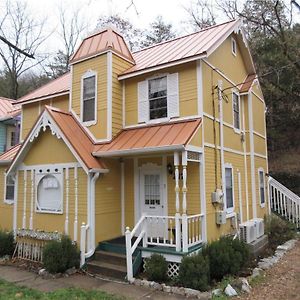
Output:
[35, 170, 64, 215]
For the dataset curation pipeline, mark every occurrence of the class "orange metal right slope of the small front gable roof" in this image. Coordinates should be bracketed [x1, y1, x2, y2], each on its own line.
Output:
[45, 105, 106, 169]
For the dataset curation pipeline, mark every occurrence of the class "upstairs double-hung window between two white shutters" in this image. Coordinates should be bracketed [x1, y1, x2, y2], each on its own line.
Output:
[148, 76, 168, 120]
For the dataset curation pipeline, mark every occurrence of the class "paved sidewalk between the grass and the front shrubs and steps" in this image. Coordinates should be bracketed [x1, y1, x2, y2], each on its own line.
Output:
[0, 265, 186, 300]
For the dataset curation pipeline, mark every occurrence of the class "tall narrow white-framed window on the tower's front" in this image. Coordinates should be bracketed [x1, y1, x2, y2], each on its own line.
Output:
[82, 73, 96, 123]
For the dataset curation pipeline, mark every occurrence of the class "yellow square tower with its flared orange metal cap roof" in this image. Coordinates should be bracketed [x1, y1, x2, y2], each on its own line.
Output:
[70, 28, 134, 142]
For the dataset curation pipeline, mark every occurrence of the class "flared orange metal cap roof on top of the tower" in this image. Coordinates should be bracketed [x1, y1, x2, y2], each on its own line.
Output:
[70, 28, 134, 63]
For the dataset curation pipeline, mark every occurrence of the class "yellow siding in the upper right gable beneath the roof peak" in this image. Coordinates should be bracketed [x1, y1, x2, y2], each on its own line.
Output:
[208, 34, 248, 87]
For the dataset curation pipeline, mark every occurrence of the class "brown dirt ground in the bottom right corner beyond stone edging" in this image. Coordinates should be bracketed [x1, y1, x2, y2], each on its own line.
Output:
[238, 241, 300, 300]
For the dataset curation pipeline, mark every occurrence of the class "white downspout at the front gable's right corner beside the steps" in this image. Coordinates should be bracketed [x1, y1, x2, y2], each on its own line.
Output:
[85, 172, 100, 258]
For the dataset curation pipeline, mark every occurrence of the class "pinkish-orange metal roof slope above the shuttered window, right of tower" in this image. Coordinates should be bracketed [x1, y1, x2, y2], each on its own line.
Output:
[121, 20, 240, 75]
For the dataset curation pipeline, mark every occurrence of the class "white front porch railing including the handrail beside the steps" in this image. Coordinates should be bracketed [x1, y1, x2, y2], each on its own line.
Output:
[125, 214, 204, 281]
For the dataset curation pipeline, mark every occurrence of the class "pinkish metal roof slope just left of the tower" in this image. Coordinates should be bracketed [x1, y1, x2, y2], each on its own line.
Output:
[17, 73, 71, 104]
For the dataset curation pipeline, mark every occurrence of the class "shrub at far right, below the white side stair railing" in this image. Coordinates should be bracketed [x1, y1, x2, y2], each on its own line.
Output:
[265, 215, 295, 250]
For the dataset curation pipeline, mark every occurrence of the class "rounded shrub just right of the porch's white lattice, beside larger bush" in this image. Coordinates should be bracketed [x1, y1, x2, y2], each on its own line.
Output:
[178, 253, 209, 291]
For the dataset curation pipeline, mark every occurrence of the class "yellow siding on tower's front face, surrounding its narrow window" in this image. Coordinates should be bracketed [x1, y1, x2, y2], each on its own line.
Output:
[72, 54, 107, 139]
